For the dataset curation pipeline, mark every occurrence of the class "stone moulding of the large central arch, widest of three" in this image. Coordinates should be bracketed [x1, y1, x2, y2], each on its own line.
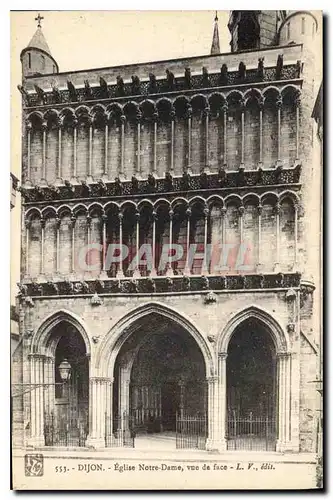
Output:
[95, 302, 215, 378]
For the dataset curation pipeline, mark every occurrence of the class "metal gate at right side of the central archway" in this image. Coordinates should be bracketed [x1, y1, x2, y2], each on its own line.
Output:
[176, 414, 208, 450]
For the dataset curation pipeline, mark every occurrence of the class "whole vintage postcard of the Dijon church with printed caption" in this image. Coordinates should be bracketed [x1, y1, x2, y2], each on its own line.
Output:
[11, 10, 323, 490]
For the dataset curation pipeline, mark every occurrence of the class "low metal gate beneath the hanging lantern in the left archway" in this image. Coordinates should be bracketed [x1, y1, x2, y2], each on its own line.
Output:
[44, 412, 88, 446]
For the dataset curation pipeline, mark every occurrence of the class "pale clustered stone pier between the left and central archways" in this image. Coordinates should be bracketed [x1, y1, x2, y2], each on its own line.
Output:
[86, 377, 109, 448]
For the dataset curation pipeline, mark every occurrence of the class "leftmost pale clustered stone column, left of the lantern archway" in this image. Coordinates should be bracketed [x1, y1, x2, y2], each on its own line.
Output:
[28, 354, 45, 447]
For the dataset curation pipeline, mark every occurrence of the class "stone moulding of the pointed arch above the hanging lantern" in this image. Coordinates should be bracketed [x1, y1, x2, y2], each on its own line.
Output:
[31, 309, 91, 356]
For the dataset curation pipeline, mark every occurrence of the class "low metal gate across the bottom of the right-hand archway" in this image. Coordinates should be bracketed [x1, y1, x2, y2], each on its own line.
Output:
[227, 412, 276, 451]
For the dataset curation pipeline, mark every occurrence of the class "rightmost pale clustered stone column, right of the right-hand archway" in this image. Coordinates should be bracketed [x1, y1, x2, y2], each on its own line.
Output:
[276, 353, 293, 452]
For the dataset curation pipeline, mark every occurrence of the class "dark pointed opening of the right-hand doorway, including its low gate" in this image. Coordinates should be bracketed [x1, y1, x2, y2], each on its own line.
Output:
[226, 318, 278, 451]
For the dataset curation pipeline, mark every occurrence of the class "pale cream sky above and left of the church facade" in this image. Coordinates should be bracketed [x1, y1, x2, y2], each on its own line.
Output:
[10, 10, 230, 303]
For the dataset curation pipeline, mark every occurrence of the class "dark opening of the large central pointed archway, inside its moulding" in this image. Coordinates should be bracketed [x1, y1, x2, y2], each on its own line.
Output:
[106, 312, 208, 449]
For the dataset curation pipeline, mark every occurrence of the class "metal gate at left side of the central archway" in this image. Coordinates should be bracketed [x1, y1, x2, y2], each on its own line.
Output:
[105, 413, 135, 448]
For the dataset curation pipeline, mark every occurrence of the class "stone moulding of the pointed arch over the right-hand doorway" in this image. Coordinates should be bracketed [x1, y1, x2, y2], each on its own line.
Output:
[217, 305, 290, 354]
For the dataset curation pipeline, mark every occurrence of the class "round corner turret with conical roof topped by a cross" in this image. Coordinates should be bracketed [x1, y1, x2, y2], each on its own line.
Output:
[20, 14, 59, 79]
